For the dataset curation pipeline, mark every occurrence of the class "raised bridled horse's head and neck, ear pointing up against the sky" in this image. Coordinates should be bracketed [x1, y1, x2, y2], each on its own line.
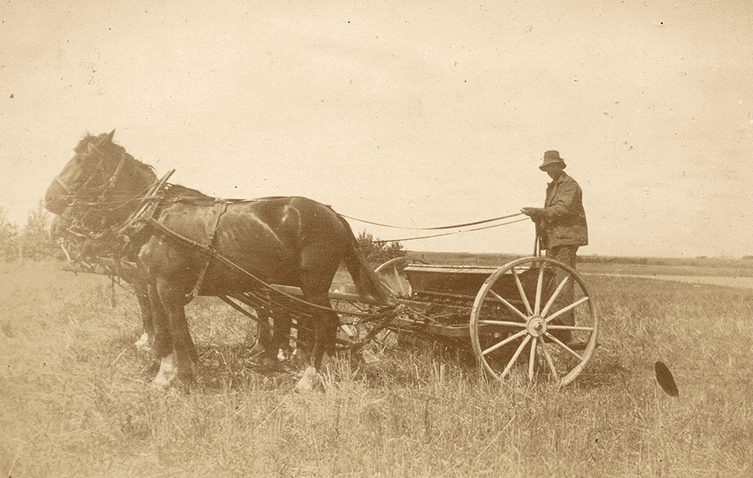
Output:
[44, 130, 157, 226]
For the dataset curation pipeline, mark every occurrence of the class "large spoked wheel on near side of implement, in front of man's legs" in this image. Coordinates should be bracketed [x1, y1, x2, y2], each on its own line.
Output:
[470, 257, 598, 387]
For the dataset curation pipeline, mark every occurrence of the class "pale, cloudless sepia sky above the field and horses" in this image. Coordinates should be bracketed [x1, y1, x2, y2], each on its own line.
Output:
[0, 0, 753, 257]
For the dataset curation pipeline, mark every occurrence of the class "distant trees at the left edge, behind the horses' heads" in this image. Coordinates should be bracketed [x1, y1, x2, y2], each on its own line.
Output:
[0, 200, 61, 262]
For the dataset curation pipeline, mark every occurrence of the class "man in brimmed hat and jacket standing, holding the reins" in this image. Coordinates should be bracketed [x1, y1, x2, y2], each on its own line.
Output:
[520, 151, 588, 342]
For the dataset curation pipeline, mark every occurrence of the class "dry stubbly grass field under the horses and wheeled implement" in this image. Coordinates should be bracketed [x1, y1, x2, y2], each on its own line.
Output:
[0, 263, 753, 477]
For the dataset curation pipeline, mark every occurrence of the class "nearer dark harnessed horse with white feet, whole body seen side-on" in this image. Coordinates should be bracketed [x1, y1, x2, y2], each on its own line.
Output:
[45, 131, 388, 389]
